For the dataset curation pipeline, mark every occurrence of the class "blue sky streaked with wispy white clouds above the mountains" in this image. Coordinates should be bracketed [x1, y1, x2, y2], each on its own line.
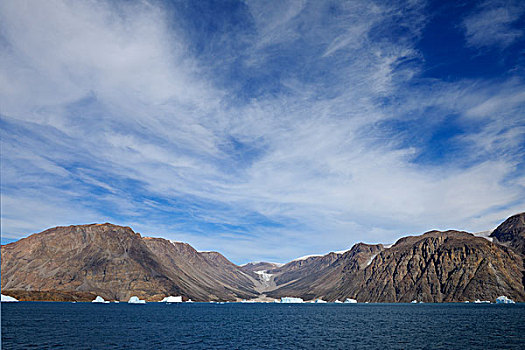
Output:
[0, 0, 525, 264]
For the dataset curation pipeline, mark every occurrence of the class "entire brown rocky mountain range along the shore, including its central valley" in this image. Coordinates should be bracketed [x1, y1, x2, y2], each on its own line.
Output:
[2, 213, 525, 302]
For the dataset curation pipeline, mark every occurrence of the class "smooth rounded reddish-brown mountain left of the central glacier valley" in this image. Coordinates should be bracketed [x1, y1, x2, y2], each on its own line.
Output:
[2, 224, 255, 300]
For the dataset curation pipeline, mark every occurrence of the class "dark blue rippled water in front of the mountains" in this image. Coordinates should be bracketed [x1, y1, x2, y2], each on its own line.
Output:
[2, 302, 525, 349]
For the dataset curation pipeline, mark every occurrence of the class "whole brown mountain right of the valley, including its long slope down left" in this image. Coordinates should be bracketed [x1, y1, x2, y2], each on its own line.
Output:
[269, 231, 525, 302]
